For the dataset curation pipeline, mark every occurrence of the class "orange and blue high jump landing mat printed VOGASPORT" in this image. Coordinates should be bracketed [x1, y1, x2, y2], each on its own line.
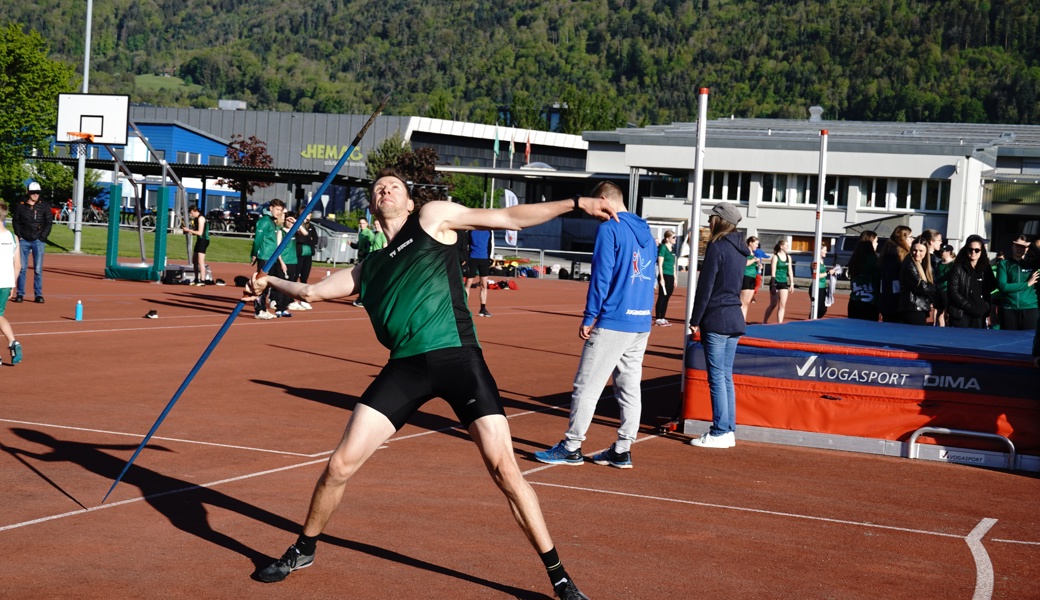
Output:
[682, 318, 1040, 472]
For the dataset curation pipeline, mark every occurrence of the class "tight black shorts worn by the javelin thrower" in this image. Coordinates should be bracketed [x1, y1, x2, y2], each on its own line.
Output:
[359, 346, 505, 431]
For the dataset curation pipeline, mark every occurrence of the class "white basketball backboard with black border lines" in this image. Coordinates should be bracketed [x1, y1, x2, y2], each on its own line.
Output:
[54, 94, 130, 146]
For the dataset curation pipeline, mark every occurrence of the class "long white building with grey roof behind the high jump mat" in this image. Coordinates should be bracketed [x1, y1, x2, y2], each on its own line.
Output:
[583, 119, 1040, 251]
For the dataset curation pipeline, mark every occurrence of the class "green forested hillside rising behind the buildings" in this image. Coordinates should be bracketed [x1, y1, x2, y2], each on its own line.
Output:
[0, 0, 1040, 131]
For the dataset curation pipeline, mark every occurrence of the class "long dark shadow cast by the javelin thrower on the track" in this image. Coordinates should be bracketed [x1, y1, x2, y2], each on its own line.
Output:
[6, 427, 548, 600]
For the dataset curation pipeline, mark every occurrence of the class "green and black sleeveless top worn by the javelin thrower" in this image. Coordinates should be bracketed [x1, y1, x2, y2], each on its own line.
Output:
[359, 212, 479, 359]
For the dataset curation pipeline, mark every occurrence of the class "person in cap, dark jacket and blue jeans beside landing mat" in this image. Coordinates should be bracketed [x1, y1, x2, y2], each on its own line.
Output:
[690, 202, 749, 448]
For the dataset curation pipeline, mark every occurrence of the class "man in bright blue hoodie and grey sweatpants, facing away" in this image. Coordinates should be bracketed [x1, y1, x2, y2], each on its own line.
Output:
[535, 182, 657, 469]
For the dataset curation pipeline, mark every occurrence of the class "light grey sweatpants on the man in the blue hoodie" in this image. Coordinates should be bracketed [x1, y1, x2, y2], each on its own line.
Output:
[564, 328, 650, 452]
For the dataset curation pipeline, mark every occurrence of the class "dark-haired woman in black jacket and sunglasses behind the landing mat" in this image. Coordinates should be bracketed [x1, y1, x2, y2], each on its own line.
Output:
[946, 235, 996, 329]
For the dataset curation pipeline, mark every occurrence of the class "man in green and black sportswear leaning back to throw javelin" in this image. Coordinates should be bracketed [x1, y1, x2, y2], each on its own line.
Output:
[246, 169, 617, 600]
